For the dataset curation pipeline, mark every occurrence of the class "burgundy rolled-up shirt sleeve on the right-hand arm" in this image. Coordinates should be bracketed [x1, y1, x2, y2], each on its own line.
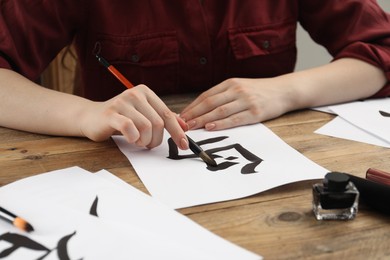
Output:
[299, 0, 390, 97]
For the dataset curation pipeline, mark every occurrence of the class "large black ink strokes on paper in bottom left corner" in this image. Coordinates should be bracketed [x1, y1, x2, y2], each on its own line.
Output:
[0, 231, 76, 260]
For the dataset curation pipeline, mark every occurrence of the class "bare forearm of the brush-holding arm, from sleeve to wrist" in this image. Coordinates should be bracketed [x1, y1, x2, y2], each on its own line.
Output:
[0, 69, 90, 136]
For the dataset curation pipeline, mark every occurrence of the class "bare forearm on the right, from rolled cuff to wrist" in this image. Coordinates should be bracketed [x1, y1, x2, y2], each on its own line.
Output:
[280, 59, 387, 111]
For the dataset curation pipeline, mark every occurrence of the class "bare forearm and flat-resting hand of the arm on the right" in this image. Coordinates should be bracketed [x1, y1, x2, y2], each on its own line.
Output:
[180, 58, 387, 130]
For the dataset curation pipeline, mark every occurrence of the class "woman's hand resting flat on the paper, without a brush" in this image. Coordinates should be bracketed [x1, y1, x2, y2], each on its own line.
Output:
[180, 78, 289, 130]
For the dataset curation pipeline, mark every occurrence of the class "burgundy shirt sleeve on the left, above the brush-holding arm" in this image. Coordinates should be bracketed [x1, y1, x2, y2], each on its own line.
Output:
[0, 0, 82, 81]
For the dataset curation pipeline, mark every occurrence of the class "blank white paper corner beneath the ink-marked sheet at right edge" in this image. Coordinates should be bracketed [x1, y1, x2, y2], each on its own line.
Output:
[315, 116, 390, 148]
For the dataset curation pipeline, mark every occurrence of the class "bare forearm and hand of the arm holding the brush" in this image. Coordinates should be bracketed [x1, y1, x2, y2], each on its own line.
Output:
[0, 69, 188, 149]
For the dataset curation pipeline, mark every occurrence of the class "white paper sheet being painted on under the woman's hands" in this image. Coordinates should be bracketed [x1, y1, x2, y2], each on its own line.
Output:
[113, 124, 327, 208]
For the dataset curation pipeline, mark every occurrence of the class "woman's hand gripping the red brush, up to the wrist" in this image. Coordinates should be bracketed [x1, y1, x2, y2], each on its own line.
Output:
[79, 85, 188, 149]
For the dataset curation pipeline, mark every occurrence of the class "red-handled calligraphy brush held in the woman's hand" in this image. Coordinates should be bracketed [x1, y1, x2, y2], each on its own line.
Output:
[95, 54, 217, 167]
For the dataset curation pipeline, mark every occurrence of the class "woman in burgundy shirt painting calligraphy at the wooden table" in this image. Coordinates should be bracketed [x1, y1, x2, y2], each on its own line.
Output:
[0, 0, 390, 149]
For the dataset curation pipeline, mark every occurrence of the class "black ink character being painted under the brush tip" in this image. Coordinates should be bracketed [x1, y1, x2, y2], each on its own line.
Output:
[167, 136, 263, 174]
